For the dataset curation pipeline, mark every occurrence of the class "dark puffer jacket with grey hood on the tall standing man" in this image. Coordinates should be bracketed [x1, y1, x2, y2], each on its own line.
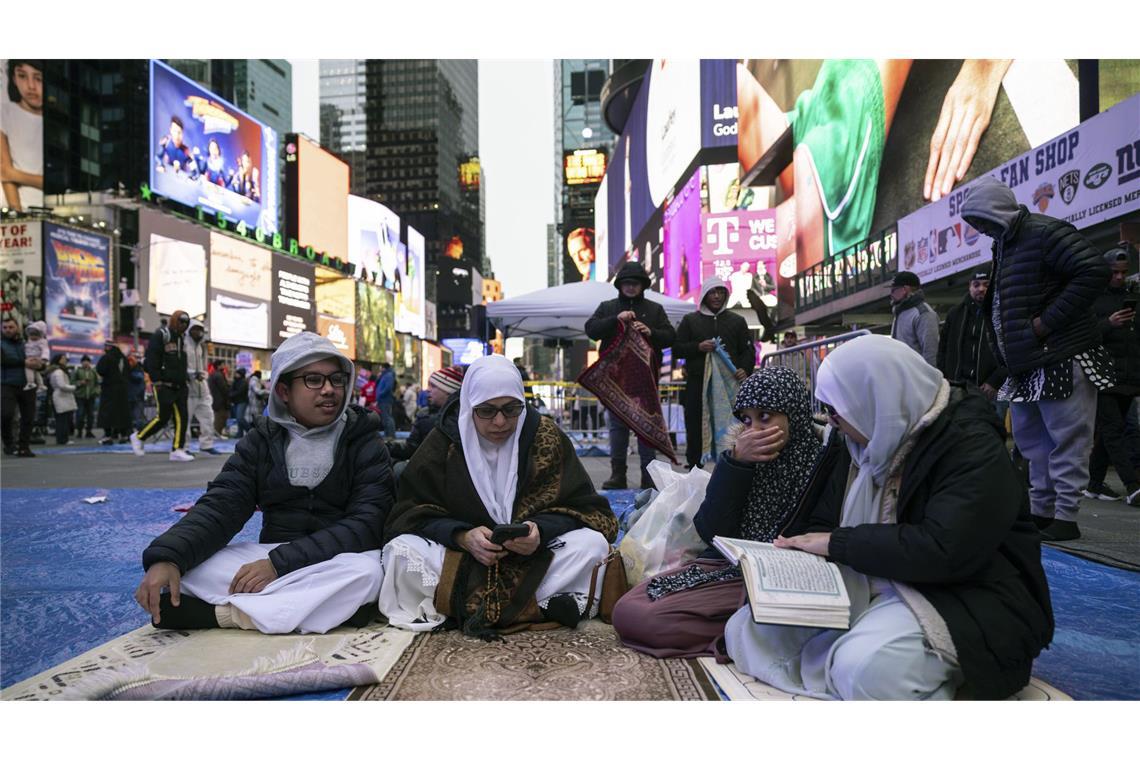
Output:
[962, 177, 1109, 375]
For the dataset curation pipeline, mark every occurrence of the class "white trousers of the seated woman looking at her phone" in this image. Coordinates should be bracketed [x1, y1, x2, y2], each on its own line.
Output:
[380, 528, 610, 631]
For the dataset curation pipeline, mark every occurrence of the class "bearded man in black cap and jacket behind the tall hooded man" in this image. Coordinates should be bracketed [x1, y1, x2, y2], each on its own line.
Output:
[938, 269, 1009, 419]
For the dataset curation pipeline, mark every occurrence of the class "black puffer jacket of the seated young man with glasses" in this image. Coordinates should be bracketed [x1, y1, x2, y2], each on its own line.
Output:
[143, 406, 396, 577]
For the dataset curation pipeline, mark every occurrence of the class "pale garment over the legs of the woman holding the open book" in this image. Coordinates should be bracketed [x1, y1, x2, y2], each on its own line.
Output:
[724, 573, 962, 700]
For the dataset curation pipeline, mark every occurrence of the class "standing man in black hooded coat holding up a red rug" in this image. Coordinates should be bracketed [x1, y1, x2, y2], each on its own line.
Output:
[586, 261, 676, 489]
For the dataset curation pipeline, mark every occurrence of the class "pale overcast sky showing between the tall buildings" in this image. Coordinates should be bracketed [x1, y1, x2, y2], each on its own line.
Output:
[290, 59, 554, 297]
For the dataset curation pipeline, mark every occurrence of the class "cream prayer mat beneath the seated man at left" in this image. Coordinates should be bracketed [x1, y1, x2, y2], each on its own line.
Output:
[0, 622, 415, 701]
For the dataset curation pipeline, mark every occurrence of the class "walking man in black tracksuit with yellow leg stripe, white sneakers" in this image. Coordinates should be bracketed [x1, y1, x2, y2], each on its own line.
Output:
[131, 311, 194, 461]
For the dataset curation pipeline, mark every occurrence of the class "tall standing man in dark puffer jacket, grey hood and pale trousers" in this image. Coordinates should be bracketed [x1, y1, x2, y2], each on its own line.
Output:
[962, 177, 1115, 541]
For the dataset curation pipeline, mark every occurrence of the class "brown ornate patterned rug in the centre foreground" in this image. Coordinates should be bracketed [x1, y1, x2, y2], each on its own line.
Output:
[349, 620, 719, 701]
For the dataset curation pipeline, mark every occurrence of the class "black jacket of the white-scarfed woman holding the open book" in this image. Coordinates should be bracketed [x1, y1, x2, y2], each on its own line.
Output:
[783, 384, 1053, 700]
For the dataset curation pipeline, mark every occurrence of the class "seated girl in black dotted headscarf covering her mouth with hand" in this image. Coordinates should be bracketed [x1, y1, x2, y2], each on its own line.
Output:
[613, 367, 822, 657]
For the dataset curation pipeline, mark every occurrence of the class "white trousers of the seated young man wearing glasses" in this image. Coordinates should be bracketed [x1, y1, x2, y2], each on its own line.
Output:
[181, 544, 383, 634]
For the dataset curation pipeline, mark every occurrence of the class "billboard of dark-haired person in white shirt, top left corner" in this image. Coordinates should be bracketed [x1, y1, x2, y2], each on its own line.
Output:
[0, 58, 43, 211]
